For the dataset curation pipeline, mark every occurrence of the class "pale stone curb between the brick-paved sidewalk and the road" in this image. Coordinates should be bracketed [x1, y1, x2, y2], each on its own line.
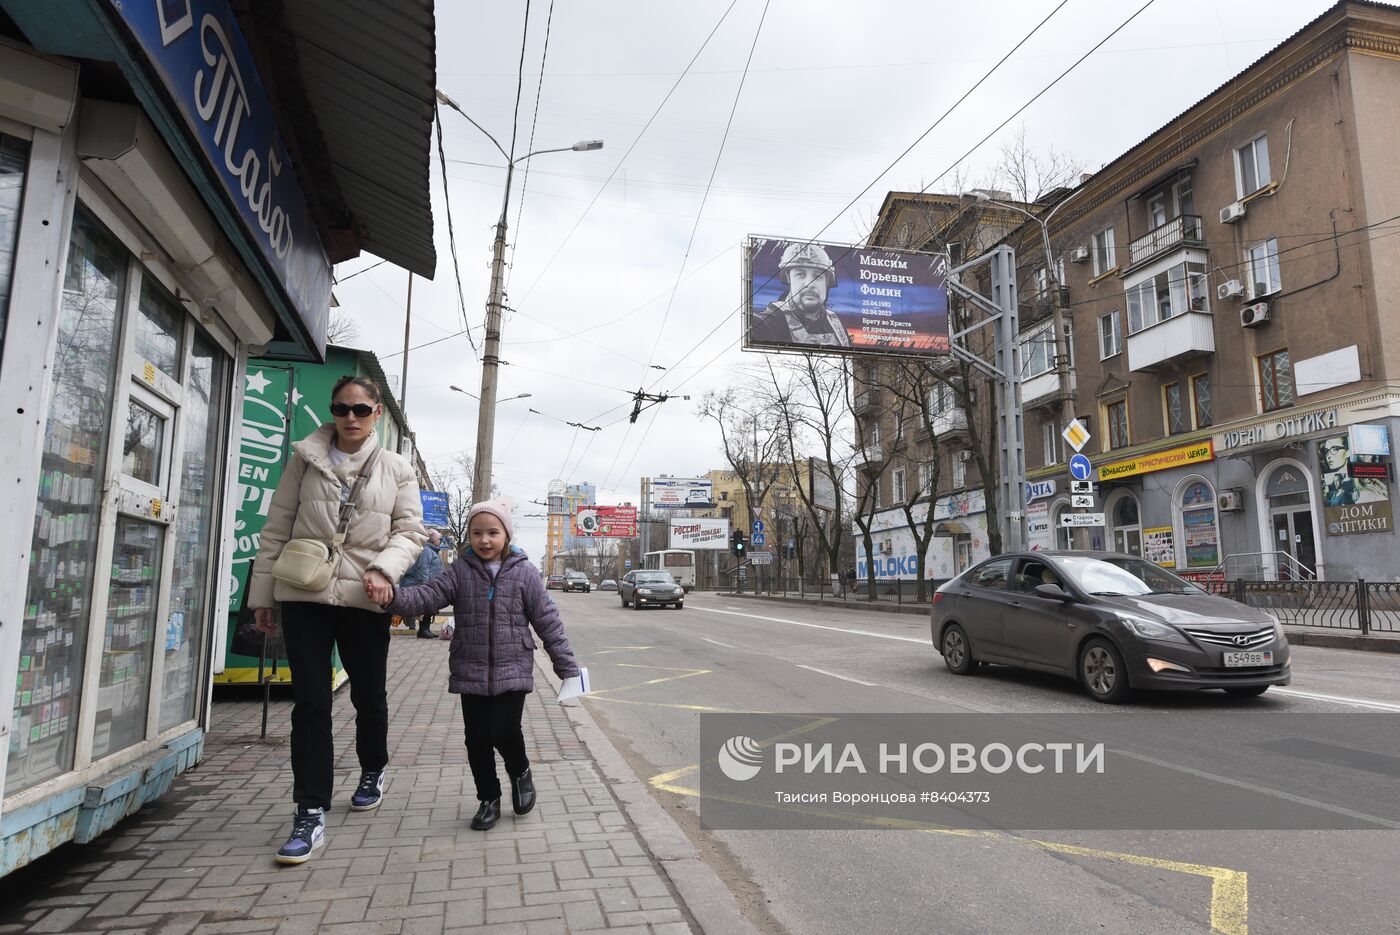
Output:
[535, 658, 759, 935]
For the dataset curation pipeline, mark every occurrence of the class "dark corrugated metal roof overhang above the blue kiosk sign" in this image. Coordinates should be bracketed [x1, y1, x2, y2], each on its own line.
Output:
[281, 0, 437, 279]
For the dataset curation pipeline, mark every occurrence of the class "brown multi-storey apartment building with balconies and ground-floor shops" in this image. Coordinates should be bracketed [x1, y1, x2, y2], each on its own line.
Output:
[857, 1, 1400, 578]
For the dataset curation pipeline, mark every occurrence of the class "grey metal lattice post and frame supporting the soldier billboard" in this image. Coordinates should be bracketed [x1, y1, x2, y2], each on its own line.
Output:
[945, 244, 1026, 551]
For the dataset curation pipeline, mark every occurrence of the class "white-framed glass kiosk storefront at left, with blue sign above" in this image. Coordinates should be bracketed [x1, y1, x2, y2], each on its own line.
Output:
[0, 0, 350, 875]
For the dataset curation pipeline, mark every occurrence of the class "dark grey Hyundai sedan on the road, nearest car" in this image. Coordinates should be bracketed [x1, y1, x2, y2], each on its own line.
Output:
[931, 551, 1292, 704]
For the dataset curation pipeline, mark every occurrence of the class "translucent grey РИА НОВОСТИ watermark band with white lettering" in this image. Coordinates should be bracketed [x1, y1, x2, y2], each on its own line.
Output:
[699, 711, 1400, 830]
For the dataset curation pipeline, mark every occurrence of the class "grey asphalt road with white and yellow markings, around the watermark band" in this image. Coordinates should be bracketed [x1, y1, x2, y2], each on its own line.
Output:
[556, 592, 1400, 935]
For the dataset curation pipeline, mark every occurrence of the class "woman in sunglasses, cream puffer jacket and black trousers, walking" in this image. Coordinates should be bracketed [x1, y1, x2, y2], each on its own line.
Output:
[248, 377, 427, 864]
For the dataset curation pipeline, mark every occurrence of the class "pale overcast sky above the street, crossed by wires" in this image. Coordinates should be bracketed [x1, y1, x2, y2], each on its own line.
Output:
[327, 0, 1344, 560]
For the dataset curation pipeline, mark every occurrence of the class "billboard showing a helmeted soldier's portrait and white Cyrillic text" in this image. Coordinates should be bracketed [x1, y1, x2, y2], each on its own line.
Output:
[743, 237, 949, 357]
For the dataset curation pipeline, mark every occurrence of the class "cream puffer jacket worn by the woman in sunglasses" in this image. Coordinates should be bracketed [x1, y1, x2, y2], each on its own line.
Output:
[248, 426, 427, 610]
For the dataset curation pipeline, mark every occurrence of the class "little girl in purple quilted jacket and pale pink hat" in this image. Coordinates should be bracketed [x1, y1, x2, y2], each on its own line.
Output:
[388, 500, 578, 831]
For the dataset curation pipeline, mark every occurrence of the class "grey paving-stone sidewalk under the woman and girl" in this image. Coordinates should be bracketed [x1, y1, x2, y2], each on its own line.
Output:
[0, 638, 699, 935]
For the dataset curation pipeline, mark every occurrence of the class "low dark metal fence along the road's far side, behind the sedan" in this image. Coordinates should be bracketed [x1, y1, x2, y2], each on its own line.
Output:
[720, 574, 1400, 634]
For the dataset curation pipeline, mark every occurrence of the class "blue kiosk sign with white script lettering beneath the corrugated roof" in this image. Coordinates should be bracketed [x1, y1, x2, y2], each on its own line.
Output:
[112, 0, 330, 354]
